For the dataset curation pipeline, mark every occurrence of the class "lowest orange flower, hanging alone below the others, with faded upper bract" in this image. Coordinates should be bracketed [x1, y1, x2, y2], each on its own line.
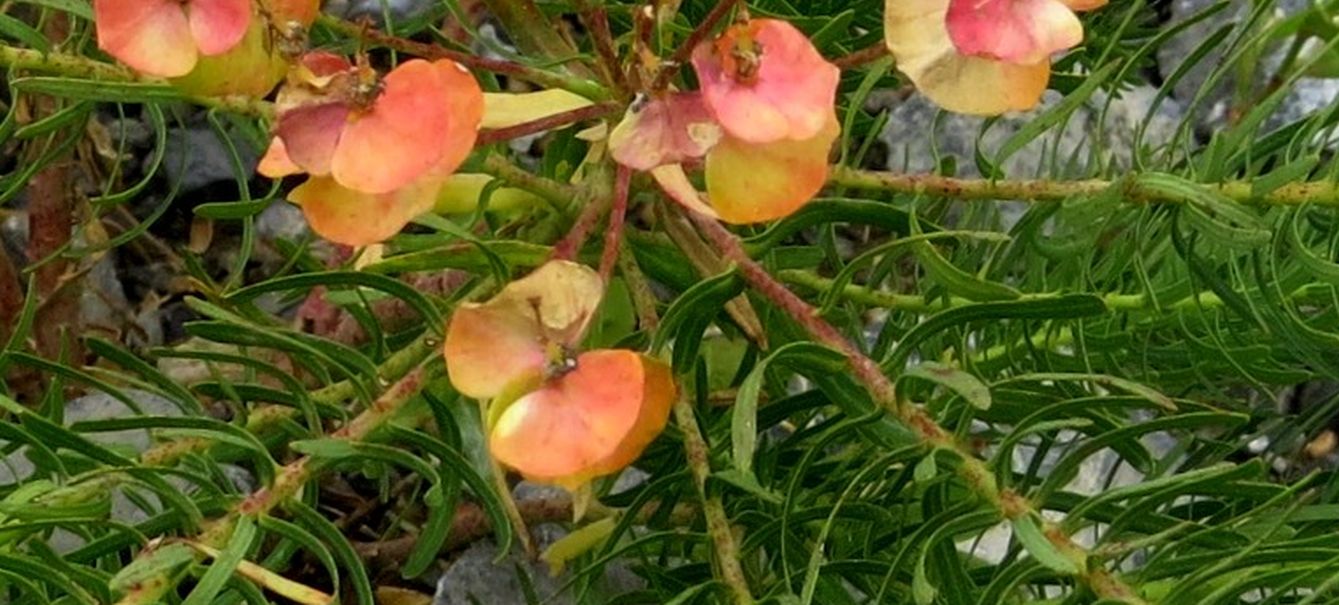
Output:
[443, 261, 676, 490]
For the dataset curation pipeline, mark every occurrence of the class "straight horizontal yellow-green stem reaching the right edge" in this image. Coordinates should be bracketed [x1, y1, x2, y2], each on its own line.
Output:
[828, 166, 1339, 206]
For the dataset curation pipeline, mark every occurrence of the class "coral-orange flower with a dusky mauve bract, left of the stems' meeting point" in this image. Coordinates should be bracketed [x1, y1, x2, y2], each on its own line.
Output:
[258, 52, 483, 245]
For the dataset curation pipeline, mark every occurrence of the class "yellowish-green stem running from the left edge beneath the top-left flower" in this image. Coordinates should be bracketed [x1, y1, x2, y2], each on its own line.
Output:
[0, 44, 274, 118]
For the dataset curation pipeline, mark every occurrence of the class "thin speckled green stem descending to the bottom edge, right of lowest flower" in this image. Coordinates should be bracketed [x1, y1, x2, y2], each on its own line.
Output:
[674, 394, 754, 605]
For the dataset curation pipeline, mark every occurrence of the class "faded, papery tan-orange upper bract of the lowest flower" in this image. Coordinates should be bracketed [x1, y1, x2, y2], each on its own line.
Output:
[443, 261, 604, 399]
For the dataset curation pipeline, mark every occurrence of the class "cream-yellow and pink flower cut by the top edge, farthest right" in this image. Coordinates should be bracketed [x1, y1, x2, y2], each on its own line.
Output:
[884, 0, 1106, 115]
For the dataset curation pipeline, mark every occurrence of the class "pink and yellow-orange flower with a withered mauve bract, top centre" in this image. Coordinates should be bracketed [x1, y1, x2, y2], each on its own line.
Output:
[609, 19, 841, 224]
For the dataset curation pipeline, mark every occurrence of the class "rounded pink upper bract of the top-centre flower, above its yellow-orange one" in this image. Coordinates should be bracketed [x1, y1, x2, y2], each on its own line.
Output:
[692, 19, 841, 143]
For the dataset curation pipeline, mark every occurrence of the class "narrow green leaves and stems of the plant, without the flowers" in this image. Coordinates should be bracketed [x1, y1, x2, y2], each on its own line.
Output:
[0, 0, 1339, 605]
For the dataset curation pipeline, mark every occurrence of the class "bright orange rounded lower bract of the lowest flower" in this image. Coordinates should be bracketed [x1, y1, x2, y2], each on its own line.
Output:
[489, 351, 676, 490]
